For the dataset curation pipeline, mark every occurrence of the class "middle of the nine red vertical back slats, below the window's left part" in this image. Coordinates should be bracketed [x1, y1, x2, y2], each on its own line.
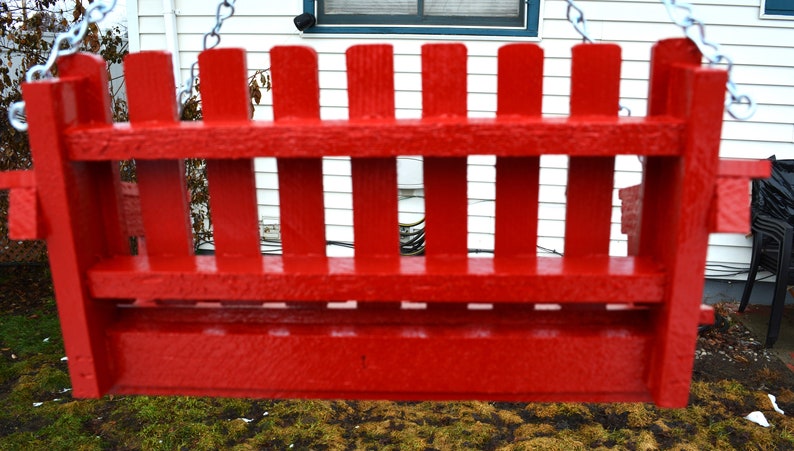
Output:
[347, 45, 400, 258]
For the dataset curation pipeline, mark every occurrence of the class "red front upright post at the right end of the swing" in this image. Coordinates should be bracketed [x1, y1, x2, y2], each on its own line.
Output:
[649, 66, 726, 405]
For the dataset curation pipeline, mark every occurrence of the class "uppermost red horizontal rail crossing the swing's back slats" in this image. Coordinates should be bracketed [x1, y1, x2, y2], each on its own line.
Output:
[66, 116, 684, 160]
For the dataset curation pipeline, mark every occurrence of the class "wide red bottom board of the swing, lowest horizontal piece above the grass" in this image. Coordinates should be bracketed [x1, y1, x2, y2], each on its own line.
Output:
[107, 308, 653, 401]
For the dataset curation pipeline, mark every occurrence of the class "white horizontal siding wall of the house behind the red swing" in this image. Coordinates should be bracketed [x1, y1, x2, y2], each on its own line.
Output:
[128, 0, 794, 279]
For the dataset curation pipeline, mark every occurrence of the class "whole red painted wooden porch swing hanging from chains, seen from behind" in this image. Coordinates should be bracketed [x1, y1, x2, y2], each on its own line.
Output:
[0, 30, 768, 406]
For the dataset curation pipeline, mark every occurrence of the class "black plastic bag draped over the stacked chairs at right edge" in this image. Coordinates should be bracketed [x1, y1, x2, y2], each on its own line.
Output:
[753, 156, 794, 225]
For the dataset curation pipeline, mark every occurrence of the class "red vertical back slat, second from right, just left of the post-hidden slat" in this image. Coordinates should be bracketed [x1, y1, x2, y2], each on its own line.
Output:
[565, 44, 620, 257]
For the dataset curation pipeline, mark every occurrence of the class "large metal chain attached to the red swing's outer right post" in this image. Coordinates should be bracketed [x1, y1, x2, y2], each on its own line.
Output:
[662, 0, 756, 121]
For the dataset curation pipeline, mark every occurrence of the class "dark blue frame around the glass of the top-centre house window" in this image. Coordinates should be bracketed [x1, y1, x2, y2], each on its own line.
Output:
[303, 0, 542, 38]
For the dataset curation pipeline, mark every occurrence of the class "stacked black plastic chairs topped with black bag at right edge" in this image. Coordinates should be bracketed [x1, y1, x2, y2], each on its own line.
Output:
[739, 157, 794, 348]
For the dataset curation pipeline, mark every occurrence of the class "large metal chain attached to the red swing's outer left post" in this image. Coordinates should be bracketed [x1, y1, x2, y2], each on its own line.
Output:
[8, 0, 116, 132]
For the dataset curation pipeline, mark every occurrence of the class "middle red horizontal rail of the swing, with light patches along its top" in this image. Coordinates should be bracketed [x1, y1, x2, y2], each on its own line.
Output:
[88, 256, 666, 303]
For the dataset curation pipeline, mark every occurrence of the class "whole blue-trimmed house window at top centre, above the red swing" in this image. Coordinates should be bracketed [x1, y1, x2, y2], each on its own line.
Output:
[304, 0, 540, 37]
